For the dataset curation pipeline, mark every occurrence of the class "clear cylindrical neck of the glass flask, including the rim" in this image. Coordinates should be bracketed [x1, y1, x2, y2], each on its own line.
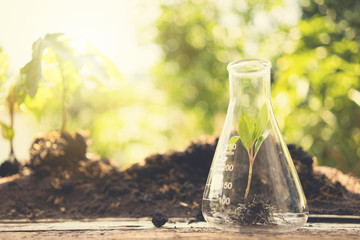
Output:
[228, 59, 271, 116]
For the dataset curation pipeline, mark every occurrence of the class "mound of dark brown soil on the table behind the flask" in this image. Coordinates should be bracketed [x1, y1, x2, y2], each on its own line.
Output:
[0, 132, 360, 221]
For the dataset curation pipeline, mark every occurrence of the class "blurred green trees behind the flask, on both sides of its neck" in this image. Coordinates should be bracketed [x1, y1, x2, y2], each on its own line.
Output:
[153, 0, 360, 176]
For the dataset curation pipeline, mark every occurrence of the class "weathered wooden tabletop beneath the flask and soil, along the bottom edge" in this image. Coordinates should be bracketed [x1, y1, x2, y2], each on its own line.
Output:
[0, 217, 360, 240]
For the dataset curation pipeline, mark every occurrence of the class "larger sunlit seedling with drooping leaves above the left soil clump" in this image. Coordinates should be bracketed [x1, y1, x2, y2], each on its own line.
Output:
[21, 33, 107, 132]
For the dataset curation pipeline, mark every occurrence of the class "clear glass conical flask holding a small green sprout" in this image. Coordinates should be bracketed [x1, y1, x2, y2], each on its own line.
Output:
[202, 59, 308, 233]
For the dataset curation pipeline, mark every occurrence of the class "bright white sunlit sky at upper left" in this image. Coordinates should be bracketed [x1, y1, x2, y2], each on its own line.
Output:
[0, 0, 160, 162]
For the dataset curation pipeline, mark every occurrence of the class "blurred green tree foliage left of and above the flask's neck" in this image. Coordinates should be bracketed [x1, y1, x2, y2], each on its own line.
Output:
[153, 0, 296, 137]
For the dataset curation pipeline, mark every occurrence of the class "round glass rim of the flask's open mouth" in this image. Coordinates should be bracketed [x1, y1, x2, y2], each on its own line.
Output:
[227, 58, 271, 74]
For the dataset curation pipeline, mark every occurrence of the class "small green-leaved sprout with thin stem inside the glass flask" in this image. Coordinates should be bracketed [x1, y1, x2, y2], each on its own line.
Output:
[229, 104, 269, 201]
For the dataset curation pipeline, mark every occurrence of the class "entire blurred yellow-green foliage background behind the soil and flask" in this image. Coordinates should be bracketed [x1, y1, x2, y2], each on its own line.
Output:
[0, 0, 360, 176]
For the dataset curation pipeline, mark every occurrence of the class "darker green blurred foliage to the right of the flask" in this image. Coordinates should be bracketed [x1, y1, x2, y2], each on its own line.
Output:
[274, 0, 360, 176]
